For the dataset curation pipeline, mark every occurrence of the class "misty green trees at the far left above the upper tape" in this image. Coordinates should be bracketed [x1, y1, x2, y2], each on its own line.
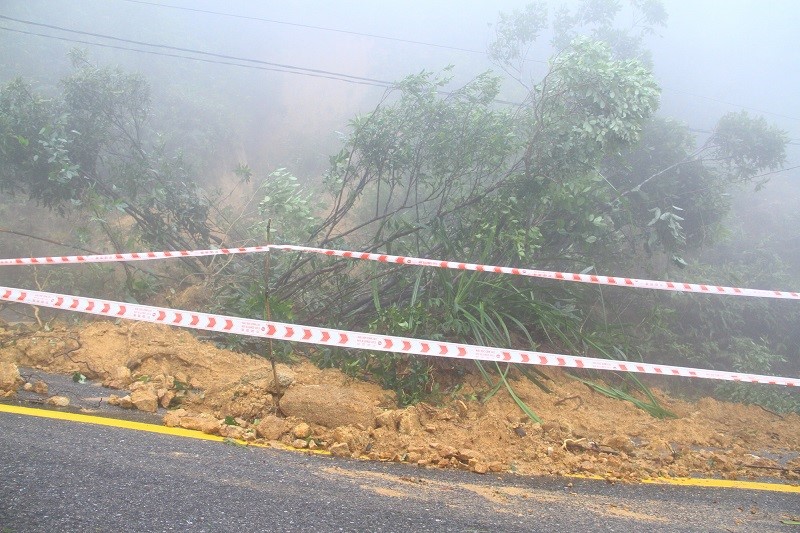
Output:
[0, 54, 217, 258]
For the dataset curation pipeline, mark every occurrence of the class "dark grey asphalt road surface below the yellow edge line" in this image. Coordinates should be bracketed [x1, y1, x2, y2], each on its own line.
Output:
[0, 406, 800, 533]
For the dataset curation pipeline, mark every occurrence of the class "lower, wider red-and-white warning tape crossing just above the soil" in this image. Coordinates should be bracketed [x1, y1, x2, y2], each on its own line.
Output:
[0, 287, 800, 387]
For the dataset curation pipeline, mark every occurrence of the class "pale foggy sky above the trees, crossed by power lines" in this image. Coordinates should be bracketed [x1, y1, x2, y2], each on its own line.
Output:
[0, 0, 800, 231]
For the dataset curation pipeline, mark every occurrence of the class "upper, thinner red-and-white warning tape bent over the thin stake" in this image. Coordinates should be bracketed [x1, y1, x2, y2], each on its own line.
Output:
[0, 244, 800, 300]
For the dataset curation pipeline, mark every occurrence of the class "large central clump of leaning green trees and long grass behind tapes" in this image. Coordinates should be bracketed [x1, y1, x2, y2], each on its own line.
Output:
[266, 1, 785, 416]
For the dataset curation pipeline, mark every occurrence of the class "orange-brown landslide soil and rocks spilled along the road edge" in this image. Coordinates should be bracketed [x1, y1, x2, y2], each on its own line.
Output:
[0, 321, 800, 484]
